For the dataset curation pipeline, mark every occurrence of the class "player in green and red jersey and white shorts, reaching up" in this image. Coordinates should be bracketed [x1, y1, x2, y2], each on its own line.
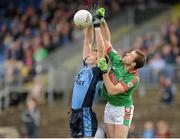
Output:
[95, 8, 146, 138]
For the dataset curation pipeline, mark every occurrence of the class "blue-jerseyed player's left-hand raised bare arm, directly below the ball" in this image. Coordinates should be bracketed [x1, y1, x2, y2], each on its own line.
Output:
[83, 25, 93, 60]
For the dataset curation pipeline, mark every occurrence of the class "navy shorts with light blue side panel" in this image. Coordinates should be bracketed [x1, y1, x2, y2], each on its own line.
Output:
[70, 107, 98, 138]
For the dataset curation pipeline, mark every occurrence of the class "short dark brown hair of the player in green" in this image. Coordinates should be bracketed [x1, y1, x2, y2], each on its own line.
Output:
[134, 49, 146, 69]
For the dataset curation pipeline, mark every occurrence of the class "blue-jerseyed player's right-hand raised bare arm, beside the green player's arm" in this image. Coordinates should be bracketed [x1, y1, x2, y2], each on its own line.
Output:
[95, 28, 105, 58]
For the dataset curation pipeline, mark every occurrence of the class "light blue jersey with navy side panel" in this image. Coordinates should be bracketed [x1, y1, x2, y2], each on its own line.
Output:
[71, 61, 102, 109]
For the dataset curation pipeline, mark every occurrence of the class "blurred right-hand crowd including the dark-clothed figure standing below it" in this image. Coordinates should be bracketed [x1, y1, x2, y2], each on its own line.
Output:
[133, 18, 180, 104]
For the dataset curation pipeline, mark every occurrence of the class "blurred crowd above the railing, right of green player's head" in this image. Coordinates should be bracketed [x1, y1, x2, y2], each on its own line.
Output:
[134, 18, 180, 67]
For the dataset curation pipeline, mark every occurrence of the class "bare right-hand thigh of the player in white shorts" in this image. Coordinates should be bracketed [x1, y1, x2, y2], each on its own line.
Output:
[114, 125, 129, 138]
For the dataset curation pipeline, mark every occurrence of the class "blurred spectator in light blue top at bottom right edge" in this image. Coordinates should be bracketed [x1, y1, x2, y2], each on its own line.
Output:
[143, 121, 155, 138]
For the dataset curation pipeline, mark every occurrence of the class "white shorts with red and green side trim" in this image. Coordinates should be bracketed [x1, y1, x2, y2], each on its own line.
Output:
[104, 103, 134, 127]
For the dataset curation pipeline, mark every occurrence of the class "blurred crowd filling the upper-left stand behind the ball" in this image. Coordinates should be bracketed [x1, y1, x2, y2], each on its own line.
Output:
[0, 0, 120, 84]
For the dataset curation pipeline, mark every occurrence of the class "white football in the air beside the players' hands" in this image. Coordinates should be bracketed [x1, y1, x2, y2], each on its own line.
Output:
[74, 10, 92, 29]
